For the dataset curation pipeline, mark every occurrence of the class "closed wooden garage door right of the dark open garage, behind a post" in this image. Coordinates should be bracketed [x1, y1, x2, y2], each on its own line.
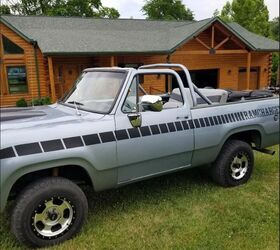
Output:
[238, 67, 259, 90]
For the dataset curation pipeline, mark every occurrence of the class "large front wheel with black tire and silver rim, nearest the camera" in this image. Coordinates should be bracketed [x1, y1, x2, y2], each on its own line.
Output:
[11, 177, 88, 247]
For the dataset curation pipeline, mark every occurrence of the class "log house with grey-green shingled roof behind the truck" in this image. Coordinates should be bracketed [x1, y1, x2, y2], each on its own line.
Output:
[0, 15, 279, 107]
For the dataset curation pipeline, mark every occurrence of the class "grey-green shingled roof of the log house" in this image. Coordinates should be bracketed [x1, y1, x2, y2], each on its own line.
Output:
[0, 15, 279, 54]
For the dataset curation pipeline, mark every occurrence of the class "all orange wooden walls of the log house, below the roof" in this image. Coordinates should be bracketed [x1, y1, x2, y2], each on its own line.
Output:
[0, 24, 271, 106]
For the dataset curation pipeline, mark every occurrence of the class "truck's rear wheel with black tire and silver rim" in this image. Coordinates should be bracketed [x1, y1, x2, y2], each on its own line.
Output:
[210, 140, 254, 187]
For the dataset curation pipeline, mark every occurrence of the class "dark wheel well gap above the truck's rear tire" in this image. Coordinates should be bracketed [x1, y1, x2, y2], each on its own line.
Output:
[227, 130, 261, 148]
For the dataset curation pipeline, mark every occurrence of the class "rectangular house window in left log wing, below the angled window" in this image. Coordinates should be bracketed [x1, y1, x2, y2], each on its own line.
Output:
[7, 66, 28, 94]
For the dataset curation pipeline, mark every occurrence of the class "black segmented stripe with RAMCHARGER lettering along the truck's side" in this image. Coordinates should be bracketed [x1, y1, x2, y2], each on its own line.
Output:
[0, 106, 279, 159]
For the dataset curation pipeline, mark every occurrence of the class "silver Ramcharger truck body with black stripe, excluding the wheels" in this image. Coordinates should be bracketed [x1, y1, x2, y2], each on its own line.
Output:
[0, 64, 279, 247]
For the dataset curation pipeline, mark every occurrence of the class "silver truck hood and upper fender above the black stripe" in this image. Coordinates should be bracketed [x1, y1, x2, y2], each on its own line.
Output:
[1, 104, 109, 148]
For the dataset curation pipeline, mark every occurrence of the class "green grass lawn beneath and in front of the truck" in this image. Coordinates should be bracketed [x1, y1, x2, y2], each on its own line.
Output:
[0, 146, 279, 250]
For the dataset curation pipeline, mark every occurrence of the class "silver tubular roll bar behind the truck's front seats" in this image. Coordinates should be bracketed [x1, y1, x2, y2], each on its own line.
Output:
[139, 63, 212, 106]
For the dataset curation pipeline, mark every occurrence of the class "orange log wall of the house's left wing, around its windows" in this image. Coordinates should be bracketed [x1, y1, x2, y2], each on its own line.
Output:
[0, 23, 49, 107]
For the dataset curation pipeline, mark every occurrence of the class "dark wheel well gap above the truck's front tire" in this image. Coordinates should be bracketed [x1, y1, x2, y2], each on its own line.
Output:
[9, 165, 93, 199]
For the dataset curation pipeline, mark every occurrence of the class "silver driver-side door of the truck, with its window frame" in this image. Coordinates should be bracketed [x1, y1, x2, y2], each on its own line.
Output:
[115, 74, 194, 184]
